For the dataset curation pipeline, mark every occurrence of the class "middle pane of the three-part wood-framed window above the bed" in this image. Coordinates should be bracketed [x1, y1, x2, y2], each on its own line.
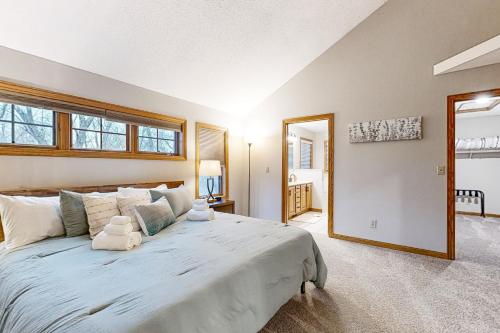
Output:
[71, 114, 128, 151]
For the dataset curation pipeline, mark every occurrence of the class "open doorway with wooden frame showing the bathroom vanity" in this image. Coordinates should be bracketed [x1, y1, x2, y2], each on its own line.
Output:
[281, 113, 334, 237]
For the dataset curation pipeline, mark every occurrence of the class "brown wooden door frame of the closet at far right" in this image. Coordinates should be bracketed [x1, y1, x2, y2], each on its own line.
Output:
[446, 88, 500, 260]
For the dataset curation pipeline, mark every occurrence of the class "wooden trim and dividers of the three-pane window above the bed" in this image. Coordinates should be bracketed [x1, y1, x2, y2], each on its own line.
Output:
[0, 81, 187, 161]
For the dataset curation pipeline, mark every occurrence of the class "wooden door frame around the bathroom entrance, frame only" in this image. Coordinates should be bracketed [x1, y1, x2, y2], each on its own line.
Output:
[281, 113, 334, 237]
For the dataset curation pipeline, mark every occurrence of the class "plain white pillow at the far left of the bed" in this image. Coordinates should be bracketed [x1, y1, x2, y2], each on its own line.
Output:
[0, 195, 64, 249]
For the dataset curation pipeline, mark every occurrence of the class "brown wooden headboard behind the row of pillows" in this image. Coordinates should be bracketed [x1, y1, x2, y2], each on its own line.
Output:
[0, 180, 184, 242]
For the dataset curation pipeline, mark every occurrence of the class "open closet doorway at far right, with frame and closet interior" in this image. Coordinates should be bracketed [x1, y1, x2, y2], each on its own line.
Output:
[447, 89, 500, 260]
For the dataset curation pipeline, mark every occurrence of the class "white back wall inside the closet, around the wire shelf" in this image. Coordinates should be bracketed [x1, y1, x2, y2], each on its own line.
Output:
[455, 116, 500, 214]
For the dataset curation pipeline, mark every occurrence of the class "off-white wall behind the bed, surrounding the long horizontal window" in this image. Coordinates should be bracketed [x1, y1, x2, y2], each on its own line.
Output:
[0, 47, 246, 212]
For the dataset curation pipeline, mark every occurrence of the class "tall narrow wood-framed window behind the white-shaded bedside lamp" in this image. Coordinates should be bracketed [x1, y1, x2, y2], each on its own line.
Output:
[195, 123, 229, 197]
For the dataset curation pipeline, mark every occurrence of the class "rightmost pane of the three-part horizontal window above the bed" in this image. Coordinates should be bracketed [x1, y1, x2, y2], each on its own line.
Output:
[139, 126, 179, 155]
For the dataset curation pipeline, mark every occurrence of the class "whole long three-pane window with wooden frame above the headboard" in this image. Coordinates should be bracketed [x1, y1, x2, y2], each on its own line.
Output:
[0, 81, 187, 160]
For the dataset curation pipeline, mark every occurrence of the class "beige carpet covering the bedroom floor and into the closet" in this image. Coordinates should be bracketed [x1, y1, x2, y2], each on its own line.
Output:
[262, 216, 500, 333]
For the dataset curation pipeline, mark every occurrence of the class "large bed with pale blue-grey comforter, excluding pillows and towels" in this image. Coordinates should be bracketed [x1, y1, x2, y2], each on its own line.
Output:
[0, 184, 327, 333]
